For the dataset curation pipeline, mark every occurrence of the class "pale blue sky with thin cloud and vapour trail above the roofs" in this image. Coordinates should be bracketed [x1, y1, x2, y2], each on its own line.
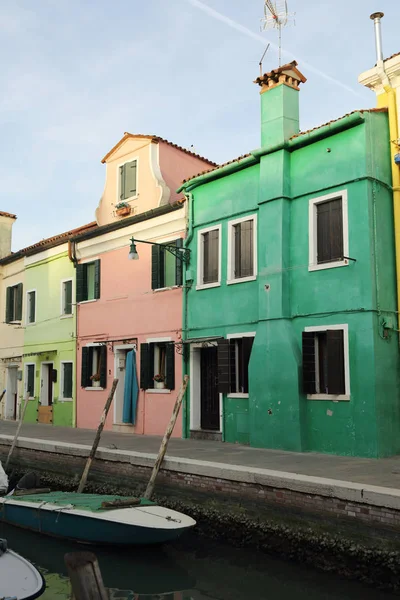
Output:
[0, 0, 400, 251]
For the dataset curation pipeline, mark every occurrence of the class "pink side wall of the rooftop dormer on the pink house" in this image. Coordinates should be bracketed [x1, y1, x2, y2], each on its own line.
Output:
[159, 142, 213, 203]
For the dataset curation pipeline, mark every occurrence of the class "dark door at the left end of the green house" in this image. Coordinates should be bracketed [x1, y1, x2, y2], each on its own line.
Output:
[200, 347, 220, 431]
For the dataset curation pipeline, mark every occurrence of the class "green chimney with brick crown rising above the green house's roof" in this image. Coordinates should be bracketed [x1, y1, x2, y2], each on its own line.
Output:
[254, 60, 307, 147]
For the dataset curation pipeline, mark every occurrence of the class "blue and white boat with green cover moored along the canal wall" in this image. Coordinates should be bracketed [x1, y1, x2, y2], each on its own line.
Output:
[0, 490, 196, 546]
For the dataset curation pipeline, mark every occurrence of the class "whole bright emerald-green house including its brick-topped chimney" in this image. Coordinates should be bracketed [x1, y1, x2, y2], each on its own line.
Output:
[179, 62, 400, 457]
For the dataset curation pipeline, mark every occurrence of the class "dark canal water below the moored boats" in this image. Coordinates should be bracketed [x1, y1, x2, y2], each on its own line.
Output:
[0, 524, 398, 600]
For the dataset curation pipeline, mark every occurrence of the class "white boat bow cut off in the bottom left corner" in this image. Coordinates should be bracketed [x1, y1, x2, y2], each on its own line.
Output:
[0, 539, 46, 600]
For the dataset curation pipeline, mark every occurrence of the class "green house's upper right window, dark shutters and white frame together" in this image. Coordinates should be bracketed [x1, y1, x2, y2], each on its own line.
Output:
[309, 191, 349, 271]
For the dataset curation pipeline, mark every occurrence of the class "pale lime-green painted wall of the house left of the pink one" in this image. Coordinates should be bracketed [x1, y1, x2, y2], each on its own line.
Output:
[23, 251, 76, 427]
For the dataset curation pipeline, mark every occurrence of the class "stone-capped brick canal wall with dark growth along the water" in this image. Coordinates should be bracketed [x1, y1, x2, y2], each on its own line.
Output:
[0, 435, 400, 591]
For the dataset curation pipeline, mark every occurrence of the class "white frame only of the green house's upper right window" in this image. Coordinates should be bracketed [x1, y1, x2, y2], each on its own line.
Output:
[308, 190, 349, 271]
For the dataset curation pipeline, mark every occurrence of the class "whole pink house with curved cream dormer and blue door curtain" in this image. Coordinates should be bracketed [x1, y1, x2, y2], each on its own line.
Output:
[70, 133, 213, 436]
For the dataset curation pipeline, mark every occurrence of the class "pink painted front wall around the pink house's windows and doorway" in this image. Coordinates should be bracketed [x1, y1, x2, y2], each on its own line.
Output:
[77, 244, 182, 437]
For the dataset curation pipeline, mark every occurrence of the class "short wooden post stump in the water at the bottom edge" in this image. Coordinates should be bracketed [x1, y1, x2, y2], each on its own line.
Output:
[64, 552, 109, 600]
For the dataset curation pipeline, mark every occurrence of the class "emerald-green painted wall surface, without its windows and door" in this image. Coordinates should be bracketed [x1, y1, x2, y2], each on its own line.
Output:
[185, 108, 400, 457]
